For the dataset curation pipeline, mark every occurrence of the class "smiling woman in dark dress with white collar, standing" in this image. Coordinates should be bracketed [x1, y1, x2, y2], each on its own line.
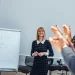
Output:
[30, 27, 54, 75]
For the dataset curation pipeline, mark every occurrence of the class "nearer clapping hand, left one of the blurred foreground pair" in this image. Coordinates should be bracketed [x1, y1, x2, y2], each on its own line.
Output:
[49, 26, 67, 51]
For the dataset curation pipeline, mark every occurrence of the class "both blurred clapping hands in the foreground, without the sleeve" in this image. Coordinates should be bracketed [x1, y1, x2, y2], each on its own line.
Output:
[49, 25, 74, 50]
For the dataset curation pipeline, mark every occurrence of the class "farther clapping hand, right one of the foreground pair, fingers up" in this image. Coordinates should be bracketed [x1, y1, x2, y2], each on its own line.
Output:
[63, 25, 72, 42]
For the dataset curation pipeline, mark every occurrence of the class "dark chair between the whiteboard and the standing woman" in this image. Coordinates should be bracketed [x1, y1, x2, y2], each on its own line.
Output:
[18, 56, 34, 75]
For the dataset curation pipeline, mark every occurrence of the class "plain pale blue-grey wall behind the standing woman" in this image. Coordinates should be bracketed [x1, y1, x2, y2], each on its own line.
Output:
[0, 0, 75, 64]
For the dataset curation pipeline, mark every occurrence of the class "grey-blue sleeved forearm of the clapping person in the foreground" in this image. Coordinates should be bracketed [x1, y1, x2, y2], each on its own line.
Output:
[61, 46, 75, 73]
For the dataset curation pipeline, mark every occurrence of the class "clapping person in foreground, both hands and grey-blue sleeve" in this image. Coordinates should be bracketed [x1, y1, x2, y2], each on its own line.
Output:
[49, 25, 75, 75]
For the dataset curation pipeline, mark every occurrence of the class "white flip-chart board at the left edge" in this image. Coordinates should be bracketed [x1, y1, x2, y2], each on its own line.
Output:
[0, 28, 20, 71]
